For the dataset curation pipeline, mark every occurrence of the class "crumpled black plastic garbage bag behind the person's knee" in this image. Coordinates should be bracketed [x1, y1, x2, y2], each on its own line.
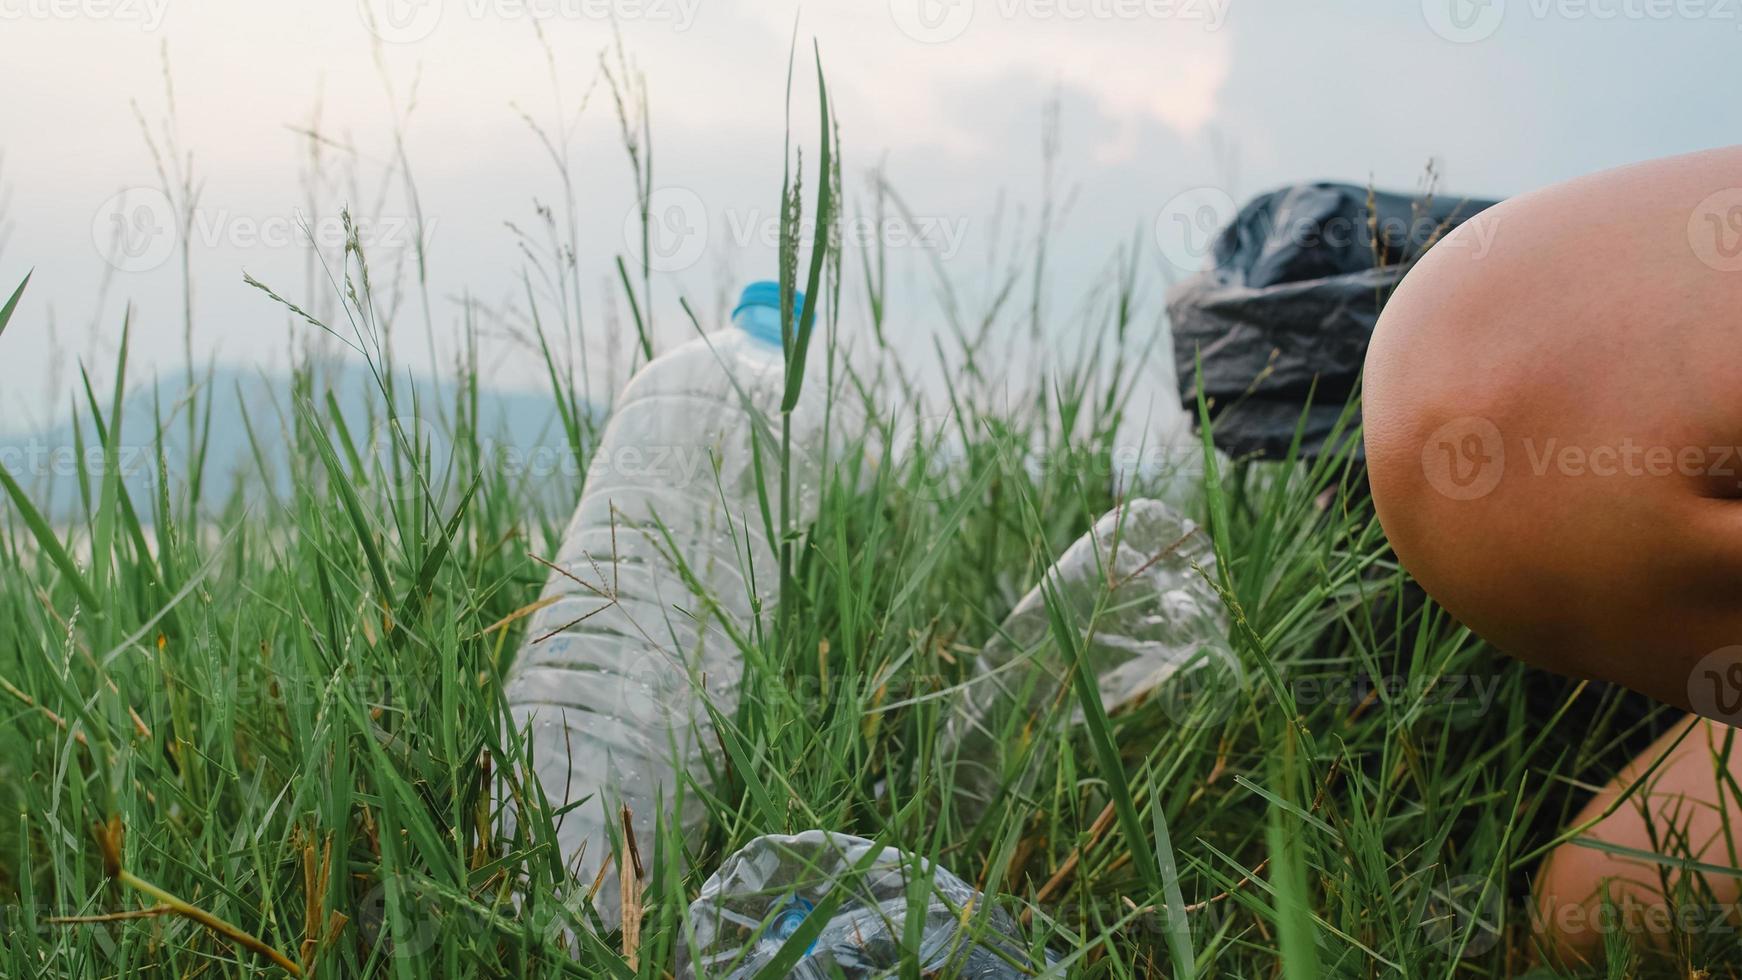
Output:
[1167, 183, 1496, 458]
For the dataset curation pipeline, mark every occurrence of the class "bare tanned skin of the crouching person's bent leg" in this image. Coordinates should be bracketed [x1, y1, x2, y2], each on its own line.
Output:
[1362, 148, 1742, 954]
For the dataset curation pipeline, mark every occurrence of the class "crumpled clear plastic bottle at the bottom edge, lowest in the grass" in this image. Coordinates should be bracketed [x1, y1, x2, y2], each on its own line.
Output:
[678, 830, 1035, 980]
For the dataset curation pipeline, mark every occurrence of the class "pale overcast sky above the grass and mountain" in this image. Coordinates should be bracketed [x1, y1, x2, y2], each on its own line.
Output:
[0, 0, 1742, 428]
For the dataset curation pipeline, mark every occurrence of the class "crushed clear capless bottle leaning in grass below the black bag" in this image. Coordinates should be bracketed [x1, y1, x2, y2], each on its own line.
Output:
[944, 500, 1240, 823]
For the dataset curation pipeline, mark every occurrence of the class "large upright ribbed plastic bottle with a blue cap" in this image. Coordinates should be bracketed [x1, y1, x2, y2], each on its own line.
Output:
[505, 282, 841, 924]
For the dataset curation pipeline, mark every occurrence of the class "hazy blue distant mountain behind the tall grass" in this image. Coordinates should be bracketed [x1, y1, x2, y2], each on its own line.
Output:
[0, 362, 580, 522]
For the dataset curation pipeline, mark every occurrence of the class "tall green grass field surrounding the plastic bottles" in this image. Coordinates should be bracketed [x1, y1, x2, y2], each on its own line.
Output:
[0, 51, 1742, 978]
